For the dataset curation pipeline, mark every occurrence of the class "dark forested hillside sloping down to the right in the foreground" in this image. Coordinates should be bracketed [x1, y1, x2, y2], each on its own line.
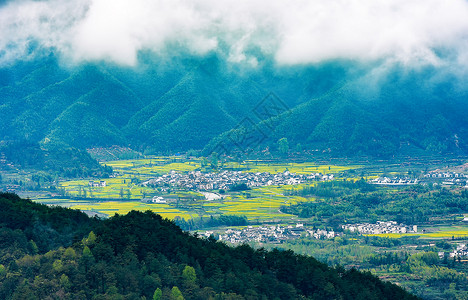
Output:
[0, 194, 416, 299]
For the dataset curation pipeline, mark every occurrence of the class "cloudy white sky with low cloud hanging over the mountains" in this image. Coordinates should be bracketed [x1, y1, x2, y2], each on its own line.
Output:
[0, 0, 468, 69]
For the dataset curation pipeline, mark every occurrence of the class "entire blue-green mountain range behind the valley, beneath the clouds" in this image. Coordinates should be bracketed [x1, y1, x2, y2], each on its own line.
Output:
[0, 56, 468, 158]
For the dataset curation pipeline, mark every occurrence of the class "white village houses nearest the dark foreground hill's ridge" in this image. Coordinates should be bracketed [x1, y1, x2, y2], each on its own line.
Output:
[214, 224, 338, 244]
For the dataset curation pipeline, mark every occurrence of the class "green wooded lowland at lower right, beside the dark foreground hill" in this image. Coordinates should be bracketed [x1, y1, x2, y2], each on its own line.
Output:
[257, 235, 468, 299]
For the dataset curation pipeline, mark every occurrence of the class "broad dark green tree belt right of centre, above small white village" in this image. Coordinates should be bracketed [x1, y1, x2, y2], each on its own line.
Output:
[281, 184, 468, 227]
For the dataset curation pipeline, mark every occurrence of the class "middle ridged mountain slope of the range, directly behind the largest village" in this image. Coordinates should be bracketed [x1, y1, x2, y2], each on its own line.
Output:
[124, 59, 264, 151]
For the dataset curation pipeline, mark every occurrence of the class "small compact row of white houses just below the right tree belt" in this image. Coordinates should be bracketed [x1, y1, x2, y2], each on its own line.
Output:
[341, 221, 418, 234]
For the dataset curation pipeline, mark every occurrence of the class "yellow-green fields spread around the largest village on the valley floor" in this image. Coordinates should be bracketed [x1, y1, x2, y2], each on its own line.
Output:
[43, 157, 352, 220]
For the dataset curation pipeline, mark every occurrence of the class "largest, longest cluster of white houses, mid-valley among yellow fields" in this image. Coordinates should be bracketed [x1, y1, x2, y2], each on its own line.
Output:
[142, 171, 334, 191]
